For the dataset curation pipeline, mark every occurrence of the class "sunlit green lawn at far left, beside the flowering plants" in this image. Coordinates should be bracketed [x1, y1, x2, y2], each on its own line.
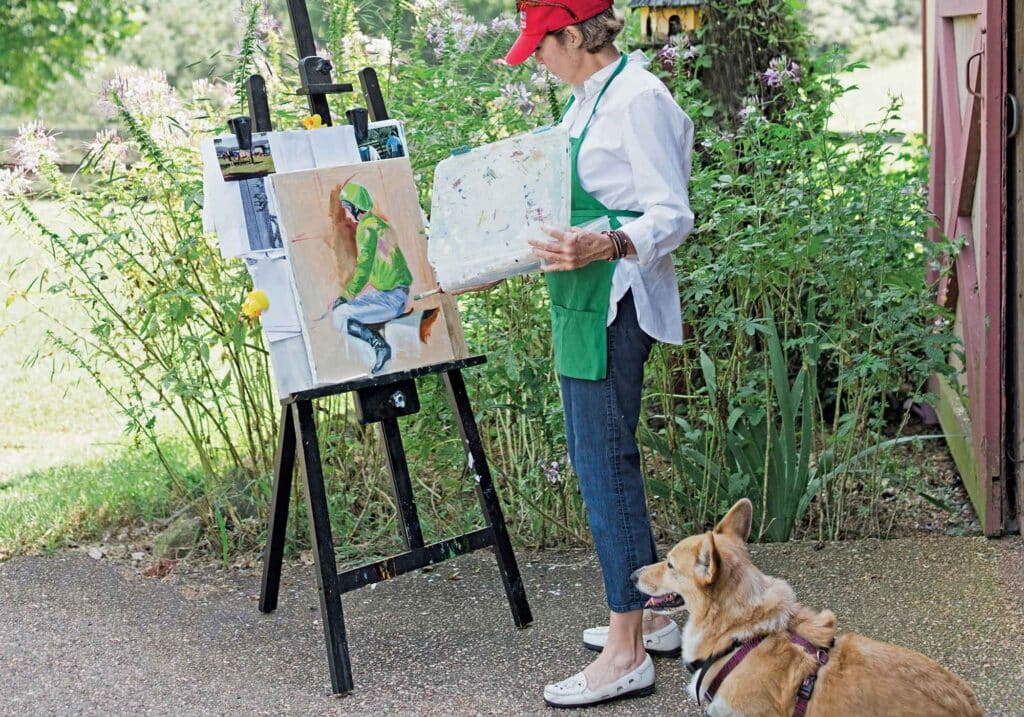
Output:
[0, 203, 187, 559]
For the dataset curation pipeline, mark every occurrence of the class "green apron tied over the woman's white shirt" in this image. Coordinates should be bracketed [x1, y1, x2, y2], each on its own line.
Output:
[545, 54, 640, 381]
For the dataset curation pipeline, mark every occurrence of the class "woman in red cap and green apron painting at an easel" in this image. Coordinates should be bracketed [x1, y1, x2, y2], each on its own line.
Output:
[506, 0, 693, 707]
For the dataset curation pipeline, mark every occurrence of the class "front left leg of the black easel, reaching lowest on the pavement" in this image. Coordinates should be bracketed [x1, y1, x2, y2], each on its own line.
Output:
[292, 399, 352, 692]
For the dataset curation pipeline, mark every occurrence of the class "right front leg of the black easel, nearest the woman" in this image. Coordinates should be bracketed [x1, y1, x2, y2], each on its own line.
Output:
[444, 369, 534, 627]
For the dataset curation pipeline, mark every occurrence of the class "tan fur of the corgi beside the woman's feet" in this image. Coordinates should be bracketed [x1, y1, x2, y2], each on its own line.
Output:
[637, 499, 983, 717]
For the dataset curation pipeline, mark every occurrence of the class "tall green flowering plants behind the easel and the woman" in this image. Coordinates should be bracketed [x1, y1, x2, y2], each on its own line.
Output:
[0, 0, 954, 558]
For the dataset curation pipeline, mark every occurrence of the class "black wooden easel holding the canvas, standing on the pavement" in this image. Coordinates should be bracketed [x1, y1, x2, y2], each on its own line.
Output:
[248, 0, 534, 693]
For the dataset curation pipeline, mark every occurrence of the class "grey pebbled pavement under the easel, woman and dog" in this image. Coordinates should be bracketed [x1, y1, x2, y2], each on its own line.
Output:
[0, 538, 1024, 717]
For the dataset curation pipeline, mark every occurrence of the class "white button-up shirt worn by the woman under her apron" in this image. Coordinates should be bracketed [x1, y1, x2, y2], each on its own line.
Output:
[561, 52, 693, 344]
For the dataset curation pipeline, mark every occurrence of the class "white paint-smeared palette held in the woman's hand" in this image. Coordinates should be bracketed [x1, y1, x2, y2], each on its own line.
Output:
[427, 127, 570, 291]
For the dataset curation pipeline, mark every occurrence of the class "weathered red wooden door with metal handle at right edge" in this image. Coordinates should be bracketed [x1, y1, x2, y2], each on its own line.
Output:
[929, 0, 1012, 536]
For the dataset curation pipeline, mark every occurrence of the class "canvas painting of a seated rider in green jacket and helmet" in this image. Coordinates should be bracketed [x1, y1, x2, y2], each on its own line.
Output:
[271, 159, 465, 383]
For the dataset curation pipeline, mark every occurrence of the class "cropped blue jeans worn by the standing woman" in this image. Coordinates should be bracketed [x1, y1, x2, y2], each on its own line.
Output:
[559, 292, 657, 613]
